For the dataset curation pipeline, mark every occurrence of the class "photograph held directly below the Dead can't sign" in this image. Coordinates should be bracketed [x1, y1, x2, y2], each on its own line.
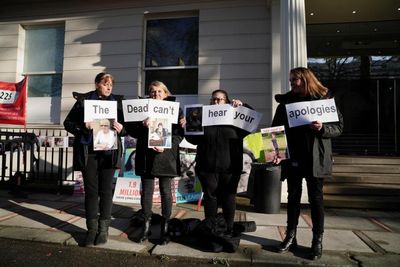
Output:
[148, 118, 172, 148]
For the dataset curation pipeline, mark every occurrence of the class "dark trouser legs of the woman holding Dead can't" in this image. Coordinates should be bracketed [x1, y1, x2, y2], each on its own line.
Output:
[140, 175, 172, 219]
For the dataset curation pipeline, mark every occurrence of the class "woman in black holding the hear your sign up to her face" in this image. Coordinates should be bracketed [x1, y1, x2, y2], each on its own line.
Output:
[186, 90, 250, 252]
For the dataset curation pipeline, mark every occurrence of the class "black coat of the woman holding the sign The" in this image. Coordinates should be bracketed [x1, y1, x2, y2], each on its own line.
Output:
[64, 91, 126, 171]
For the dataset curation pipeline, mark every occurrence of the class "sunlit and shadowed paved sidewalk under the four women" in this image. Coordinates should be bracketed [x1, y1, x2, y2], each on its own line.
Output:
[0, 190, 400, 266]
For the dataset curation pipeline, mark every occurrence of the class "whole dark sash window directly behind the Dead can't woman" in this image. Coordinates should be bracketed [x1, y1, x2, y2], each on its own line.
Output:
[144, 16, 199, 95]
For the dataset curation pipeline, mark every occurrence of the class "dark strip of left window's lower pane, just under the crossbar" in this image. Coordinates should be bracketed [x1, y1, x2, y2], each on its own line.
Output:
[28, 74, 62, 97]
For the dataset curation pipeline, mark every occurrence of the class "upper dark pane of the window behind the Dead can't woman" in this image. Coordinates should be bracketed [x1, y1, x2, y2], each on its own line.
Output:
[145, 17, 199, 67]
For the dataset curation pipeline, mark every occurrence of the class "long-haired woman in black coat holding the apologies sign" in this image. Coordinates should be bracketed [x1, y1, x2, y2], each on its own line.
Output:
[272, 67, 343, 260]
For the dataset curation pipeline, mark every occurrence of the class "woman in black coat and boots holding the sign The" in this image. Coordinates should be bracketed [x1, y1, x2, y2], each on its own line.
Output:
[64, 72, 126, 246]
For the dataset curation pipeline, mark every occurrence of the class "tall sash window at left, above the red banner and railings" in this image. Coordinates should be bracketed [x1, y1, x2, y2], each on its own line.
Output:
[23, 24, 65, 123]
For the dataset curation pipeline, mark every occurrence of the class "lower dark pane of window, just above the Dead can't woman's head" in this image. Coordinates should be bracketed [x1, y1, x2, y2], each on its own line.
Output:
[145, 69, 198, 95]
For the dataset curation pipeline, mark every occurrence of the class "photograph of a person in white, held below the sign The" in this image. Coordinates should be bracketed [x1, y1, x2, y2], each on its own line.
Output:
[93, 119, 118, 151]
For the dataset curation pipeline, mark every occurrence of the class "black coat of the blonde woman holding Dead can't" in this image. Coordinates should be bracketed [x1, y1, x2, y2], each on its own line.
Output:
[125, 97, 183, 178]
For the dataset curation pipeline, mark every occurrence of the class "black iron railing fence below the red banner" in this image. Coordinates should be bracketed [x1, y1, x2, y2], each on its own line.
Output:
[0, 128, 74, 191]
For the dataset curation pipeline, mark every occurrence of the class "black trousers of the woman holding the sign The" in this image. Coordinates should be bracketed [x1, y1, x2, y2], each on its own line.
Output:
[82, 154, 115, 220]
